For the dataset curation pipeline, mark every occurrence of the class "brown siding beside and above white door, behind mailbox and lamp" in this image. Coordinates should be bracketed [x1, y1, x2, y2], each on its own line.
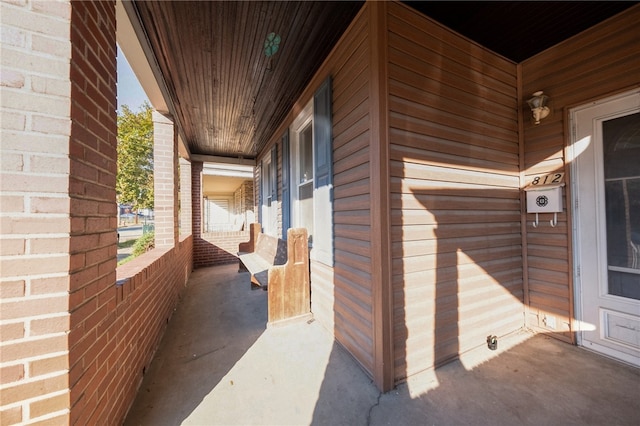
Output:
[521, 6, 640, 341]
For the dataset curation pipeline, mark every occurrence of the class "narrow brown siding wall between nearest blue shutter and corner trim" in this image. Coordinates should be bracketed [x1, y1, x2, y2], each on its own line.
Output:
[324, 10, 374, 375]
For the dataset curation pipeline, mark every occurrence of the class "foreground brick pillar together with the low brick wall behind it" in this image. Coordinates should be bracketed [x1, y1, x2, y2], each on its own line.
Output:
[0, 0, 193, 425]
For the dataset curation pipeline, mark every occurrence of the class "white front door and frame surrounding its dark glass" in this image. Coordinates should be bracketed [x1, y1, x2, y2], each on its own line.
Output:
[567, 89, 640, 366]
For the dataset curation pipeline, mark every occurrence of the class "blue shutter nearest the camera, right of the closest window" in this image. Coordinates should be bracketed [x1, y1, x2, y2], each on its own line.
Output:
[313, 77, 334, 266]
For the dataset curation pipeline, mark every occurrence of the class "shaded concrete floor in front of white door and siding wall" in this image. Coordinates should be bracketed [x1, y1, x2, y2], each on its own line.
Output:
[312, 332, 640, 425]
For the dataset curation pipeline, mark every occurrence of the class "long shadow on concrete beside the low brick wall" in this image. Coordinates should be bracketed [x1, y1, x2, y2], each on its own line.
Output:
[125, 264, 267, 425]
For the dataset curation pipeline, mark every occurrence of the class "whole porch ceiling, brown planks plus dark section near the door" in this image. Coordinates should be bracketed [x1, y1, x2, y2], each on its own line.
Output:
[127, 0, 637, 159]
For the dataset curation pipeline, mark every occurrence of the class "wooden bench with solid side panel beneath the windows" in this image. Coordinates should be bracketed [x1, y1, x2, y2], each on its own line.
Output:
[238, 223, 311, 325]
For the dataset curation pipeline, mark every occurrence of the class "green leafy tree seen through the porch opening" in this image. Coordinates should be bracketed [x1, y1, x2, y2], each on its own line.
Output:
[116, 102, 153, 221]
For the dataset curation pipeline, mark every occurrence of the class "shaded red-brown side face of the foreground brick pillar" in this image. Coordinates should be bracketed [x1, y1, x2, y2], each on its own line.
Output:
[68, 1, 117, 424]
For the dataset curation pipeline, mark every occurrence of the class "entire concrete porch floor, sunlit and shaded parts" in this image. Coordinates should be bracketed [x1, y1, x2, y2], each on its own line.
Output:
[125, 265, 640, 425]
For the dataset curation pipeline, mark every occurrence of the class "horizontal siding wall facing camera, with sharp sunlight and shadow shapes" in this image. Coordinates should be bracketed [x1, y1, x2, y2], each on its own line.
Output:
[388, 3, 524, 380]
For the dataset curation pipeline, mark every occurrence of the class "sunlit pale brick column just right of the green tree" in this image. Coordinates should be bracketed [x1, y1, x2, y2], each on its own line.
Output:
[153, 111, 179, 247]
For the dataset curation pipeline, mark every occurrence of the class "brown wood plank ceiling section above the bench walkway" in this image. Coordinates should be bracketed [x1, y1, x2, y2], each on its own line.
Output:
[134, 1, 362, 158]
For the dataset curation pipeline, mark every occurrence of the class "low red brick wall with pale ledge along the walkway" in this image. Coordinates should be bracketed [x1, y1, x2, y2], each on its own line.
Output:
[112, 237, 193, 424]
